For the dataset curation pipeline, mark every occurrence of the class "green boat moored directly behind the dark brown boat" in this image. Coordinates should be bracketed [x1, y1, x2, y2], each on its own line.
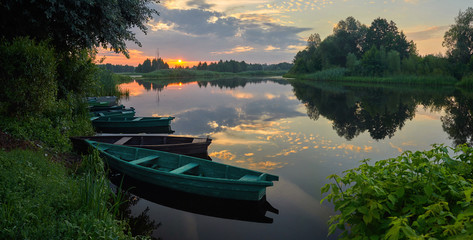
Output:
[92, 117, 174, 133]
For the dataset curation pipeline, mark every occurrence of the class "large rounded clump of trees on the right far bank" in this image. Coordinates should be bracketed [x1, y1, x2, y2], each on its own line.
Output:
[289, 17, 415, 76]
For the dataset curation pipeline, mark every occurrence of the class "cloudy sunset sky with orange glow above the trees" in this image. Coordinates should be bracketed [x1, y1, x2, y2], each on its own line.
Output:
[97, 0, 473, 67]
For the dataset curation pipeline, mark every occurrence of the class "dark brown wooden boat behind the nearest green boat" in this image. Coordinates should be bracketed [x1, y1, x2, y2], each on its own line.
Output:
[71, 134, 212, 158]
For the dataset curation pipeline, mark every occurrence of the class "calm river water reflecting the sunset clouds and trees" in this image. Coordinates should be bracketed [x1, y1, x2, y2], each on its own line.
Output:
[115, 78, 473, 240]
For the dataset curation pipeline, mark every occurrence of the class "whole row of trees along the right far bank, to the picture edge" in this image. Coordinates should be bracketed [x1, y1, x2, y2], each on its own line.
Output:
[289, 8, 473, 82]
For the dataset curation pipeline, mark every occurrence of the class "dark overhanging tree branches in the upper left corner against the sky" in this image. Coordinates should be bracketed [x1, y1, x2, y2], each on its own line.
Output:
[0, 0, 159, 57]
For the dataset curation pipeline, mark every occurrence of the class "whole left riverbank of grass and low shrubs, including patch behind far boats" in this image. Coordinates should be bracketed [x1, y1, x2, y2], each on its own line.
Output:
[0, 70, 148, 239]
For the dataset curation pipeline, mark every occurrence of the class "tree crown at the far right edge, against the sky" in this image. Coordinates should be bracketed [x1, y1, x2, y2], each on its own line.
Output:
[442, 7, 473, 64]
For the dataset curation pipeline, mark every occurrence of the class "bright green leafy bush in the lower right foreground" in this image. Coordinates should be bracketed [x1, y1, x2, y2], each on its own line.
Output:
[322, 145, 473, 240]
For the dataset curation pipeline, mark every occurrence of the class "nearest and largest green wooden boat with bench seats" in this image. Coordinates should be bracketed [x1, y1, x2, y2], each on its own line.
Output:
[86, 140, 279, 201]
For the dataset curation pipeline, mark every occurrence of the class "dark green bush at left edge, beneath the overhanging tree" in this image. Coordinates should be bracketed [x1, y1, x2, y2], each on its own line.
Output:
[0, 38, 57, 116]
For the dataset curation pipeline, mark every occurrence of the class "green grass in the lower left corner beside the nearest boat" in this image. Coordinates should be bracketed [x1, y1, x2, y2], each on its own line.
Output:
[0, 150, 138, 239]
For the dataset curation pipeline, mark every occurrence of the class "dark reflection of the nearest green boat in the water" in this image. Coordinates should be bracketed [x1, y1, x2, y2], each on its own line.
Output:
[110, 172, 279, 223]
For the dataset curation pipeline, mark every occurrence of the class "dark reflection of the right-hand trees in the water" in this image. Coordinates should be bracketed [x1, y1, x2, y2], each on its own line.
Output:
[291, 81, 473, 145]
